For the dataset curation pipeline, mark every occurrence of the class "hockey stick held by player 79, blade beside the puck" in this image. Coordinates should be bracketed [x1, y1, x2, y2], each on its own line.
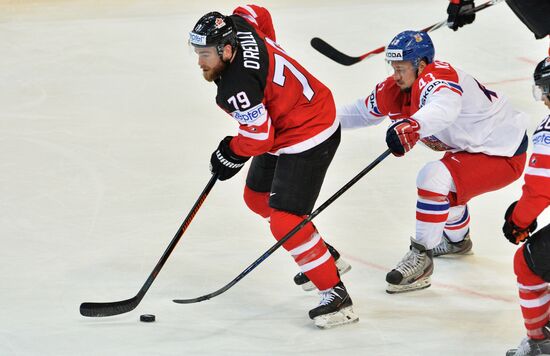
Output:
[80, 174, 218, 317]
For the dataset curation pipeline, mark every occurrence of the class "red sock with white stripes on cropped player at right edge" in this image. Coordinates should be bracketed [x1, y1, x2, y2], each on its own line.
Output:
[514, 245, 550, 339]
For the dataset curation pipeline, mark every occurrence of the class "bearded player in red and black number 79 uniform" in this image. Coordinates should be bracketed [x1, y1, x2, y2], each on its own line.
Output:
[189, 5, 358, 328]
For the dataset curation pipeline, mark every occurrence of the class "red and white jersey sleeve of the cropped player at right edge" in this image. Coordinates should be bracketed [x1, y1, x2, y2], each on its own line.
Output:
[512, 115, 550, 228]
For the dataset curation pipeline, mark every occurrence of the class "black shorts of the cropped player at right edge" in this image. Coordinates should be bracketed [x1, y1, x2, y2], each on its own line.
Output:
[523, 225, 550, 282]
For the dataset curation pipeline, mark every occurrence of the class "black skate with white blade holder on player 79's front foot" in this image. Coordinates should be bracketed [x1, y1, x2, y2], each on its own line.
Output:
[309, 281, 359, 329]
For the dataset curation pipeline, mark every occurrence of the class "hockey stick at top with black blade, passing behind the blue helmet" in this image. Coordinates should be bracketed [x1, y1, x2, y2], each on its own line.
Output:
[311, 0, 502, 66]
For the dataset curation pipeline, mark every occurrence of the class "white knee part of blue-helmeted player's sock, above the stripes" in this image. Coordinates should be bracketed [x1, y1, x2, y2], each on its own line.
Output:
[416, 161, 456, 196]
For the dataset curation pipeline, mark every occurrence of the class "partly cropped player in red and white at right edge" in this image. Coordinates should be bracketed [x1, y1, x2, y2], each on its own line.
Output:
[502, 57, 550, 356]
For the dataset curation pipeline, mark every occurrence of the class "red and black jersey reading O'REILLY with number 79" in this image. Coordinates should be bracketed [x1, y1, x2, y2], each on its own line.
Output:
[216, 5, 339, 157]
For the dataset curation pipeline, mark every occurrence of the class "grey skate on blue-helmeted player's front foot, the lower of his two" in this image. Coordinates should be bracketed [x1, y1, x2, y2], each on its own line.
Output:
[386, 238, 433, 294]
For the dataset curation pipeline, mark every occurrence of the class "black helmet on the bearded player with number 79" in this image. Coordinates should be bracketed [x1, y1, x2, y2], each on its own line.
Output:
[189, 11, 237, 56]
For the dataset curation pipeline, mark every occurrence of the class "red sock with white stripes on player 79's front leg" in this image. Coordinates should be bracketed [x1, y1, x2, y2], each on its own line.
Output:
[271, 210, 340, 290]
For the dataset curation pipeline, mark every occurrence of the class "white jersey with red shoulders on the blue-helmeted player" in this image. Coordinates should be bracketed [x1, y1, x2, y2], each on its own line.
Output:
[338, 61, 529, 157]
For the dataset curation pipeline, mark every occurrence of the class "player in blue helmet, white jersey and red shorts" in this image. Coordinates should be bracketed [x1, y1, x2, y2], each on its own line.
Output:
[338, 31, 529, 293]
